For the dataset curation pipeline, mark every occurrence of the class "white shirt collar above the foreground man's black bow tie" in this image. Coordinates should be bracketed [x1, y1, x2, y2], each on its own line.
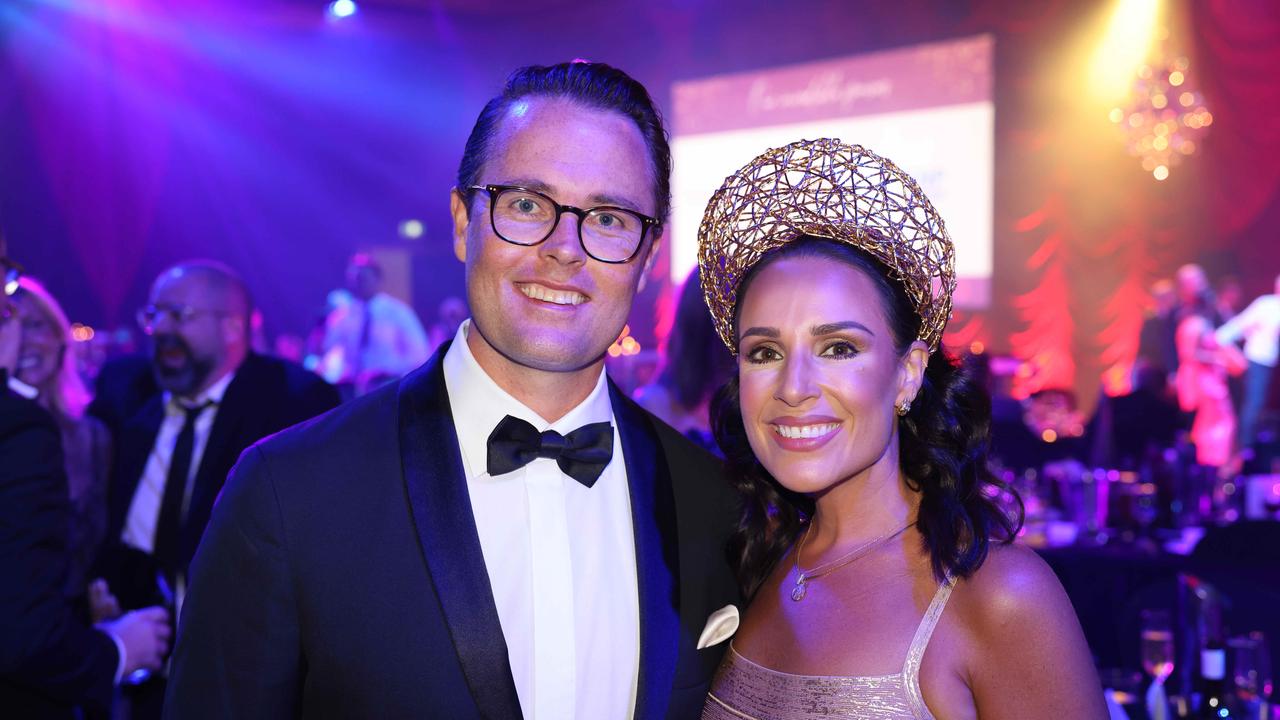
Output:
[443, 319, 613, 478]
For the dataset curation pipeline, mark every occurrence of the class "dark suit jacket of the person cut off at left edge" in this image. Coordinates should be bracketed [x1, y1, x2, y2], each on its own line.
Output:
[0, 370, 119, 717]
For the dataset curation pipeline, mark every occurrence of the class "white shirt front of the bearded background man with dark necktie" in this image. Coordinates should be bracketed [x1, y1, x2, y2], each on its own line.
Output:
[120, 372, 236, 553]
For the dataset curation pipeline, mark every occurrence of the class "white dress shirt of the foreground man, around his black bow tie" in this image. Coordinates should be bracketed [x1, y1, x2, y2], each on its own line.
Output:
[443, 320, 640, 720]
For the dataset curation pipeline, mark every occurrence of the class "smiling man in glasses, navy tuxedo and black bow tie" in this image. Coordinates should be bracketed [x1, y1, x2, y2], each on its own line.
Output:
[165, 63, 740, 720]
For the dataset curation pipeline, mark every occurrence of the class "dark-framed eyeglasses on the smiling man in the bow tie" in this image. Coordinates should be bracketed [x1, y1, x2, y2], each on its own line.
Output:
[467, 184, 662, 264]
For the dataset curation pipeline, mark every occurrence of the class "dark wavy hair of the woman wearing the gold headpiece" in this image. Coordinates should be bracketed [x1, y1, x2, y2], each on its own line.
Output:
[712, 237, 1023, 597]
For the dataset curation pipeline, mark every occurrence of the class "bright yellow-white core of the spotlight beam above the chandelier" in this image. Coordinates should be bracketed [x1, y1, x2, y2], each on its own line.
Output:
[1089, 0, 1160, 100]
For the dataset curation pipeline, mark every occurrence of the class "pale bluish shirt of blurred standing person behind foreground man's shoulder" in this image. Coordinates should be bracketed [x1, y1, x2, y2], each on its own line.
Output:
[320, 292, 431, 383]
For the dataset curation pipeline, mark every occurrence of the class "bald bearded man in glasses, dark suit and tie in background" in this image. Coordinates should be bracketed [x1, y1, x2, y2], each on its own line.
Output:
[99, 260, 338, 717]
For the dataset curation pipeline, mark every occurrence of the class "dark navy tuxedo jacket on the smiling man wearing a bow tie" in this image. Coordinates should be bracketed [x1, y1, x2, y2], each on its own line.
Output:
[165, 347, 739, 719]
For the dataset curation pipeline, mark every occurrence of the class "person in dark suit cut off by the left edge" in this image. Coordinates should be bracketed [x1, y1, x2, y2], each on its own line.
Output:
[0, 237, 170, 719]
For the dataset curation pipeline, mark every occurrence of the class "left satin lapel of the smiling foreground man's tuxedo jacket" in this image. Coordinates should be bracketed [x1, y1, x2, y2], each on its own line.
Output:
[399, 343, 521, 719]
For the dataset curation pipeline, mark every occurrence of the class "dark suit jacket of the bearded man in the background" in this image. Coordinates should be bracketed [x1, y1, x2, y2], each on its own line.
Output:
[100, 355, 339, 594]
